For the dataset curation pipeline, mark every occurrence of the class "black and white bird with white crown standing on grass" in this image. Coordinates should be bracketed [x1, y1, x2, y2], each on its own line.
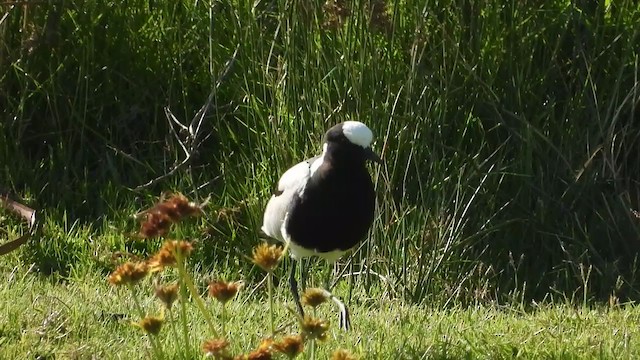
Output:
[262, 121, 382, 329]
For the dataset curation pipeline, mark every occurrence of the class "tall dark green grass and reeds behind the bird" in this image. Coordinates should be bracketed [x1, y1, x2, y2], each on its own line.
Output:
[0, 0, 640, 358]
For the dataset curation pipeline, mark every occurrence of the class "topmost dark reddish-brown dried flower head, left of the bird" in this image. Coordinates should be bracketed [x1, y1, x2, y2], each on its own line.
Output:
[137, 194, 204, 238]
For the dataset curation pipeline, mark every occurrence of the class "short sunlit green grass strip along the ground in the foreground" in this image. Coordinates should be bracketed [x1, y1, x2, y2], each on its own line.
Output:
[0, 258, 640, 359]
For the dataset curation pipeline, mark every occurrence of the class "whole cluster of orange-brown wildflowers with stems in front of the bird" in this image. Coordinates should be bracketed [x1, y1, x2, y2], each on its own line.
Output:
[108, 195, 353, 360]
